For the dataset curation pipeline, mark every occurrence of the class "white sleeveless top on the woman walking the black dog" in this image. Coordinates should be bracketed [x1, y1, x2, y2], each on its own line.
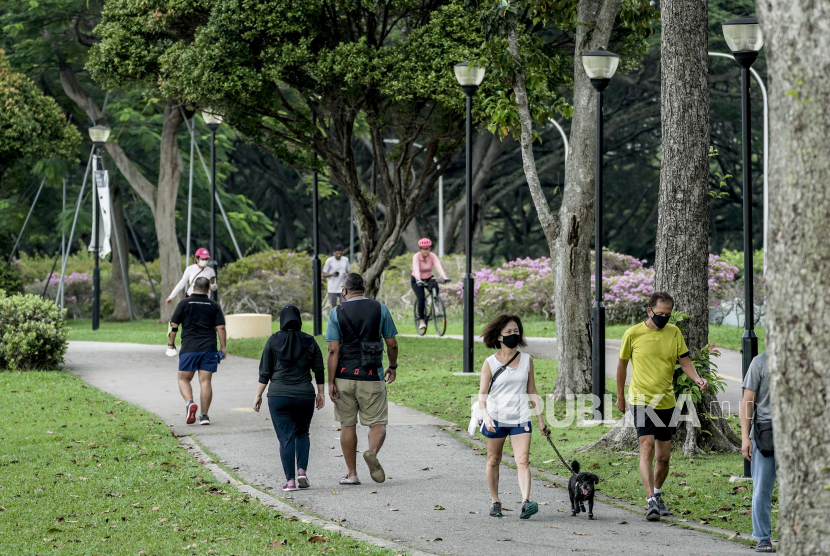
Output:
[487, 353, 531, 426]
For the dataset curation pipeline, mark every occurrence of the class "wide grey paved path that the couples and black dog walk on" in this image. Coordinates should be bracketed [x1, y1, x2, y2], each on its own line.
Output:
[66, 342, 748, 556]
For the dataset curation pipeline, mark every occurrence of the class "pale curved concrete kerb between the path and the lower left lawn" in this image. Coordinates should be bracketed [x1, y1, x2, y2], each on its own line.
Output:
[176, 436, 435, 556]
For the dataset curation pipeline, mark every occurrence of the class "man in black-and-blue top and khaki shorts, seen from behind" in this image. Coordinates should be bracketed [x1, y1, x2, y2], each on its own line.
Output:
[326, 273, 398, 485]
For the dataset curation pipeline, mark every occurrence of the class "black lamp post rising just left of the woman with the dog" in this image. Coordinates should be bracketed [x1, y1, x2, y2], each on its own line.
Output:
[454, 61, 484, 373]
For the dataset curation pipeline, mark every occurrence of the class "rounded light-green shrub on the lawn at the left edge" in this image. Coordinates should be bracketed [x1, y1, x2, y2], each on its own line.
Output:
[0, 294, 68, 371]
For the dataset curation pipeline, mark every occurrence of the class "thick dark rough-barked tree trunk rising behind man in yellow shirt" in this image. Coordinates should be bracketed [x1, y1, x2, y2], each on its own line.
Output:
[654, 0, 710, 354]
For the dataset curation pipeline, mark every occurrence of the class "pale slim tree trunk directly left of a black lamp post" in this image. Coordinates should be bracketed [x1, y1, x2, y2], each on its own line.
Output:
[556, 0, 622, 400]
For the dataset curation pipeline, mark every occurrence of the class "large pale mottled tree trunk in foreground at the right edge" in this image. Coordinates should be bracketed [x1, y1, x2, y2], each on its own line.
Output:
[756, 0, 830, 555]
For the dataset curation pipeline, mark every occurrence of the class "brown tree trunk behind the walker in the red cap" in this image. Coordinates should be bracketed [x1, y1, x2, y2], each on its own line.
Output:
[153, 100, 185, 322]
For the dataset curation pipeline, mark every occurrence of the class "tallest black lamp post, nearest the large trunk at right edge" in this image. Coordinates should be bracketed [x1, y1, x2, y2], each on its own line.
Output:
[723, 13, 764, 477]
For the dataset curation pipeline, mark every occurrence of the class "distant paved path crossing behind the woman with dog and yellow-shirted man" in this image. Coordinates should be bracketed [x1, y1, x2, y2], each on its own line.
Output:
[402, 334, 743, 415]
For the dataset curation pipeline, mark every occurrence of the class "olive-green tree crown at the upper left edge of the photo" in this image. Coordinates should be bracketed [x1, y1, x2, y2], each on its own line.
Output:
[0, 50, 81, 174]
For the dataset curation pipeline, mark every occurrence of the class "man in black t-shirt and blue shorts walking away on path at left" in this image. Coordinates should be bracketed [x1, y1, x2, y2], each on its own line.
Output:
[167, 278, 227, 425]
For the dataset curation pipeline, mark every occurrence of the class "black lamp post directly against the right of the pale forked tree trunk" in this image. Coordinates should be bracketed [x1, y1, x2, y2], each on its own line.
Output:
[582, 47, 620, 420]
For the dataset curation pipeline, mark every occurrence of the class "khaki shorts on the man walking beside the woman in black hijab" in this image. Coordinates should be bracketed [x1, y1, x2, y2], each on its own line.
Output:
[334, 378, 389, 427]
